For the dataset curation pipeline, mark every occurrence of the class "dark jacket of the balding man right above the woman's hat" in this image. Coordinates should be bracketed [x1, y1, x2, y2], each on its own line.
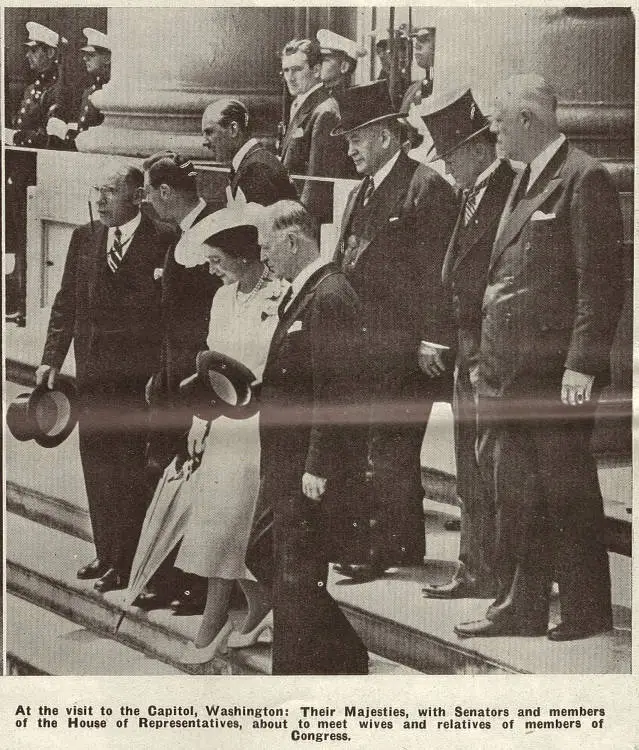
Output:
[229, 143, 297, 206]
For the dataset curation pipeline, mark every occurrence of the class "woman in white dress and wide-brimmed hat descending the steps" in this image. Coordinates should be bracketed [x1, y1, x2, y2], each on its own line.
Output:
[175, 204, 286, 663]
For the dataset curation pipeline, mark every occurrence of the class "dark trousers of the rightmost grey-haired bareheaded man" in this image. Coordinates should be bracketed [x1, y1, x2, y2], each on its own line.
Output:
[479, 399, 612, 627]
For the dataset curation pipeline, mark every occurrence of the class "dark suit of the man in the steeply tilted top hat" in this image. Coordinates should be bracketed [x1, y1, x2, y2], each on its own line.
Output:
[442, 161, 515, 588]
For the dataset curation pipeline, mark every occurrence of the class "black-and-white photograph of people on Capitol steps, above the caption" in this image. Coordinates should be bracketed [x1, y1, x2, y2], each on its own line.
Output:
[0, 5, 635, 747]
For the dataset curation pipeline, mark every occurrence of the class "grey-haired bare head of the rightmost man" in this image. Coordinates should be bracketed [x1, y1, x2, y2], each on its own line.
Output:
[491, 73, 560, 163]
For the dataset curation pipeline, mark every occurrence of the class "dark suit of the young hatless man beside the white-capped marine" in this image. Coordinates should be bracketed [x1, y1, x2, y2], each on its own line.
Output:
[280, 86, 352, 223]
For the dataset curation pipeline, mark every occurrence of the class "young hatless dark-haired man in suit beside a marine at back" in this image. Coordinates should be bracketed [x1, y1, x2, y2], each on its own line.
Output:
[280, 39, 351, 223]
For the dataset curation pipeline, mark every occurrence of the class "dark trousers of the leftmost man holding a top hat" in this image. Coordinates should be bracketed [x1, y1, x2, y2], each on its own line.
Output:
[79, 415, 152, 575]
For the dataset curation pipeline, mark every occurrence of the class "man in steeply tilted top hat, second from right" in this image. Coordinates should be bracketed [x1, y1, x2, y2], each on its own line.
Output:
[422, 89, 515, 598]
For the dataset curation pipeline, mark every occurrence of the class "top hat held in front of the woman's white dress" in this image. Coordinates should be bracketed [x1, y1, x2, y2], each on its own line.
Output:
[180, 351, 258, 422]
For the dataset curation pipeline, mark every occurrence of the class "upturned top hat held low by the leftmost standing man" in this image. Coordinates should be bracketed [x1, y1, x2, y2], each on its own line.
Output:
[7, 376, 78, 448]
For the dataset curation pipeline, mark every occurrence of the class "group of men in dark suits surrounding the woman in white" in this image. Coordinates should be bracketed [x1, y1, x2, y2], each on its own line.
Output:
[13, 19, 622, 674]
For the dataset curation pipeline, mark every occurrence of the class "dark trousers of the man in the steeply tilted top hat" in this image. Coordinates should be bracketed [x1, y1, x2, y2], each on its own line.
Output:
[452, 364, 495, 587]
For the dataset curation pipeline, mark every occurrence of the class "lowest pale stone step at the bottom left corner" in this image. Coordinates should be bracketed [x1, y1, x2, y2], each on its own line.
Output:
[7, 594, 182, 676]
